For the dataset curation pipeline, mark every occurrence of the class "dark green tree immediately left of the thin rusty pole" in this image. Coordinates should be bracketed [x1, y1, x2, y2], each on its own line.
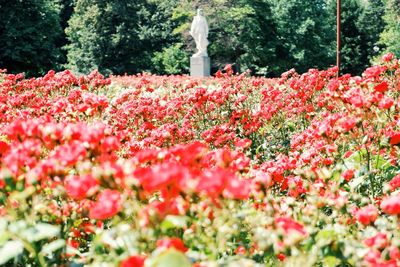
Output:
[271, 0, 335, 72]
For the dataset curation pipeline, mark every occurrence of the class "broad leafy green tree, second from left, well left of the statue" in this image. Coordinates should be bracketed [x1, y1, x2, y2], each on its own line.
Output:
[66, 0, 146, 74]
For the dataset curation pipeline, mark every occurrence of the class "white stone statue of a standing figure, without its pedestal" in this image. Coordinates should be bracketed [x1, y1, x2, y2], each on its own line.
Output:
[190, 8, 208, 57]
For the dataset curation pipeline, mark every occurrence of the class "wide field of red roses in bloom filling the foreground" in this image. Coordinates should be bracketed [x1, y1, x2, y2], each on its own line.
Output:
[0, 56, 400, 267]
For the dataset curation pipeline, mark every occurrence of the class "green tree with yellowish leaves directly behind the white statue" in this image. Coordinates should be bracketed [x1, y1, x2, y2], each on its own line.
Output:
[174, 0, 277, 73]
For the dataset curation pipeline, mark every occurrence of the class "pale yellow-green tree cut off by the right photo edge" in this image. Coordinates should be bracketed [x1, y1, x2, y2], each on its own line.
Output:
[379, 0, 400, 57]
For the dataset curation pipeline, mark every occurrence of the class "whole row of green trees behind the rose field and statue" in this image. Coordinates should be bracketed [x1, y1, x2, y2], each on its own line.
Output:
[0, 0, 400, 76]
